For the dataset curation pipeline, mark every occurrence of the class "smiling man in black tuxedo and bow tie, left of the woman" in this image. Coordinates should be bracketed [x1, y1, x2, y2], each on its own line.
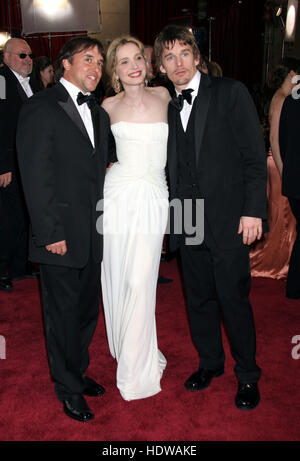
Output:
[17, 37, 114, 421]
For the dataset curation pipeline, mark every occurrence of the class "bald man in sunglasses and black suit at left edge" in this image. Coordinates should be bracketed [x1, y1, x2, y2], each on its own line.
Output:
[0, 38, 36, 291]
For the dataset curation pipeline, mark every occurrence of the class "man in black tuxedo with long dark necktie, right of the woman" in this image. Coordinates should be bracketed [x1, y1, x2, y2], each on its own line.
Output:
[155, 25, 267, 410]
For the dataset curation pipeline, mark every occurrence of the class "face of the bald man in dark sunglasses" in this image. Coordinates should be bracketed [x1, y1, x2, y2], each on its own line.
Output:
[4, 39, 32, 77]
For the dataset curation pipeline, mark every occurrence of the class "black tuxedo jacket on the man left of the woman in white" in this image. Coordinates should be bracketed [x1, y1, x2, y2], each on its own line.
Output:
[17, 83, 115, 268]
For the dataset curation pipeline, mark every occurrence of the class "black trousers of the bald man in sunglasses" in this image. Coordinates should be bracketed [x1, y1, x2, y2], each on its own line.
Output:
[0, 173, 29, 278]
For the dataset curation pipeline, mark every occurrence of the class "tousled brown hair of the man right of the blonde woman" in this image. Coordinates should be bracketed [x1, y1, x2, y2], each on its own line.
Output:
[154, 24, 200, 70]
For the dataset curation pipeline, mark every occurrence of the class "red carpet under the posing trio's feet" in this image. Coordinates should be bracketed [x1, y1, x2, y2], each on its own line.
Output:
[0, 261, 300, 441]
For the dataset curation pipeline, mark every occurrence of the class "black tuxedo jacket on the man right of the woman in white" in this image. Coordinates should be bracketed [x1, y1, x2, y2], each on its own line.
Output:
[168, 74, 267, 251]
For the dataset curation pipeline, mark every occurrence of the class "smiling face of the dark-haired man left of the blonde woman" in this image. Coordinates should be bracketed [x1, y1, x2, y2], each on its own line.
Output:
[63, 46, 104, 93]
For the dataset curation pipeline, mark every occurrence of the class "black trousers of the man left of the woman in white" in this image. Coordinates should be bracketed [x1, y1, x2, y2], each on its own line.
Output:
[40, 258, 100, 401]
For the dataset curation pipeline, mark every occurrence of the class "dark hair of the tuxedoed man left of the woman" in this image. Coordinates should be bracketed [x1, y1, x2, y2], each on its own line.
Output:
[55, 37, 105, 81]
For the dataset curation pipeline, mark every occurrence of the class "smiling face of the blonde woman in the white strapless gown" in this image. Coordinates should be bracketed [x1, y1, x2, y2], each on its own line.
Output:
[115, 43, 147, 87]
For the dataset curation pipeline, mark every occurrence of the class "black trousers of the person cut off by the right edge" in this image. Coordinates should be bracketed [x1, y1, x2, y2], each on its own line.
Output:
[286, 197, 300, 298]
